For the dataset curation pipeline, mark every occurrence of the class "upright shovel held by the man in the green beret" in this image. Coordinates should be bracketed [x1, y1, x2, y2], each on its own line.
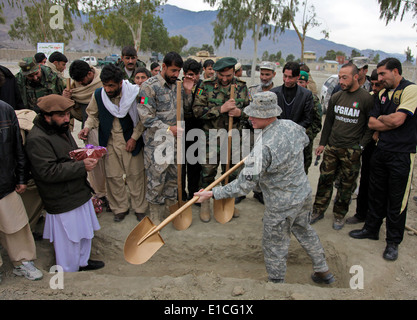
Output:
[213, 84, 235, 224]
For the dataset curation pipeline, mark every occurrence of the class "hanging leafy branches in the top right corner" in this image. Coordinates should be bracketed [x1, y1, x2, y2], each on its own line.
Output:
[378, 0, 417, 27]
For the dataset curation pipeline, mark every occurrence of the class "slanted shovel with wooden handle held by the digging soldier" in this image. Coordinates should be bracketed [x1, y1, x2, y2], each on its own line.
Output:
[124, 158, 246, 264]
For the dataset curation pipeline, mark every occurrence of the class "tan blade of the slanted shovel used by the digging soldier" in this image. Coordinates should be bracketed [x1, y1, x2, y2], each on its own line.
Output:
[124, 217, 165, 264]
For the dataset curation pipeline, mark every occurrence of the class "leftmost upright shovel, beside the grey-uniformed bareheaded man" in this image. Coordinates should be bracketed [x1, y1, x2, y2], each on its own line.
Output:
[169, 81, 193, 231]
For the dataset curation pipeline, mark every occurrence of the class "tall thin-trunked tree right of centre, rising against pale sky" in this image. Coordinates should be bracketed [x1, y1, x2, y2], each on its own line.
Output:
[280, 0, 329, 62]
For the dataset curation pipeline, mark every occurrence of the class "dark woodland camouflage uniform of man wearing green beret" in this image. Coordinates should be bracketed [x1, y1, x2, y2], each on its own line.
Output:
[193, 78, 249, 188]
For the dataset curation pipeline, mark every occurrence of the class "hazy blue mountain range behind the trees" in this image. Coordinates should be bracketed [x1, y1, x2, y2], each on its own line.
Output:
[0, 4, 405, 62]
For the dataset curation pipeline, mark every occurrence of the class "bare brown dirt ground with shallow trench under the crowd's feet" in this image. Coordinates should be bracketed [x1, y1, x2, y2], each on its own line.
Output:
[0, 66, 417, 301]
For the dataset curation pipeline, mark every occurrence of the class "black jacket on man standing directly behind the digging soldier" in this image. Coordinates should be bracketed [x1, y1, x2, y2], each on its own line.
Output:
[271, 85, 314, 129]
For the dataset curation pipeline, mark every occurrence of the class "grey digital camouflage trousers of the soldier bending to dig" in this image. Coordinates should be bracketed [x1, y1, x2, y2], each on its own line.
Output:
[262, 196, 329, 280]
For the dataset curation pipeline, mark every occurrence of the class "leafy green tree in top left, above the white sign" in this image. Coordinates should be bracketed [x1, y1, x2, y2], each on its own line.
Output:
[8, 0, 79, 46]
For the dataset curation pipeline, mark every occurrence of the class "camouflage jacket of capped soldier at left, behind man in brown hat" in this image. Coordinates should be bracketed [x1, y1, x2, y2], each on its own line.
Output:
[16, 66, 66, 113]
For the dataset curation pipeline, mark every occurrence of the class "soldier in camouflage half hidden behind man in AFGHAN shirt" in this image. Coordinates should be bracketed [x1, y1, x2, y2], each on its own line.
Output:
[298, 71, 323, 175]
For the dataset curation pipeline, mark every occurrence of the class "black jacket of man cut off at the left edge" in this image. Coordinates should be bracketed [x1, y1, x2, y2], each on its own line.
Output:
[0, 100, 28, 199]
